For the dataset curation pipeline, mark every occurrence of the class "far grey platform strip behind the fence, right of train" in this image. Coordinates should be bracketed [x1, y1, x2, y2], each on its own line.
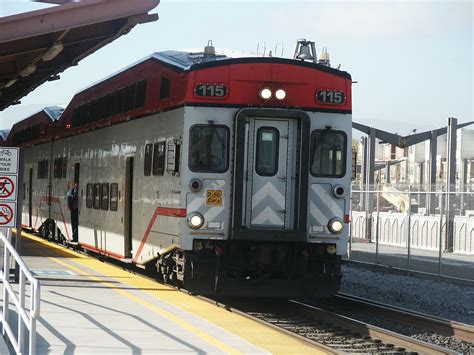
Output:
[347, 239, 474, 282]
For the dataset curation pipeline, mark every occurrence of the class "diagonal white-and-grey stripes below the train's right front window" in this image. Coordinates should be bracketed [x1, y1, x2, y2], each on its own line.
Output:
[309, 184, 344, 232]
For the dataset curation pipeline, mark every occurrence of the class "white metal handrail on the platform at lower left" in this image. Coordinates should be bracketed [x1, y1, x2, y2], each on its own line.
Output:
[0, 228, 40, 355]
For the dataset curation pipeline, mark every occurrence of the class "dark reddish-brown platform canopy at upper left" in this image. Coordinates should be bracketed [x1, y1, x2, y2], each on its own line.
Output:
[0, 0, 159, 111]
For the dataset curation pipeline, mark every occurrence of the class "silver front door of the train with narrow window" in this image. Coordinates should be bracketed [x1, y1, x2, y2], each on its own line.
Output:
[245, 118, 296, 229]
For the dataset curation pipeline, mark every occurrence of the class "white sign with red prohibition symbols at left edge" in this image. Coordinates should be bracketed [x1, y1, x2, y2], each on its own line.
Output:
[0, 147, 20, 227]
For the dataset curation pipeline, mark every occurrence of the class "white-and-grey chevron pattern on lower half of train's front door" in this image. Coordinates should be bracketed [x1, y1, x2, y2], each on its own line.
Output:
[251, 181, 285, 227]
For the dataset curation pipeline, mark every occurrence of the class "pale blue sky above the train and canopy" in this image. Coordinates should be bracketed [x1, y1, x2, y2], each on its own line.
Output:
[0, 0, 474, 134]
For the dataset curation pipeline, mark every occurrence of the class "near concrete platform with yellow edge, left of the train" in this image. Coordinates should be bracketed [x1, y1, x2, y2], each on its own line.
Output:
[7, 234, 318, 354]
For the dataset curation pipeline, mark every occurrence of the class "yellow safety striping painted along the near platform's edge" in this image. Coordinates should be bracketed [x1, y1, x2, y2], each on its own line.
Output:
[23, 233, 324, 354]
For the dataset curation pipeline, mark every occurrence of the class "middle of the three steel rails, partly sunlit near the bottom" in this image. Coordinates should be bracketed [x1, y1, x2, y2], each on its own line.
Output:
[290, 300, 458, 354]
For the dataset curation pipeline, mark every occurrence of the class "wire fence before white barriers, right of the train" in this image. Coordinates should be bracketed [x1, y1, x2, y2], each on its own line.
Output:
[348, 185, 474, 279]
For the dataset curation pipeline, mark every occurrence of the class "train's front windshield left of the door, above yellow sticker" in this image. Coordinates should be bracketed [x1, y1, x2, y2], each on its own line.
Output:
[189, 125, 229, 173]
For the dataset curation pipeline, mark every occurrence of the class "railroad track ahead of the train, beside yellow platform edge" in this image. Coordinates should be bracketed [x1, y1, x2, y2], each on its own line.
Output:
[210, 300, 457, 354]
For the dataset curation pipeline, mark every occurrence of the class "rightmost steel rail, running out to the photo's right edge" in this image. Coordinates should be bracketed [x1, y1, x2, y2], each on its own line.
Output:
[336, 293, 474, 343]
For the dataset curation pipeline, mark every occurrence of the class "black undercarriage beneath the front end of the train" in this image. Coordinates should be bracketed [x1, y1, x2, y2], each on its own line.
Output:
[156, 240, 342, 298]
